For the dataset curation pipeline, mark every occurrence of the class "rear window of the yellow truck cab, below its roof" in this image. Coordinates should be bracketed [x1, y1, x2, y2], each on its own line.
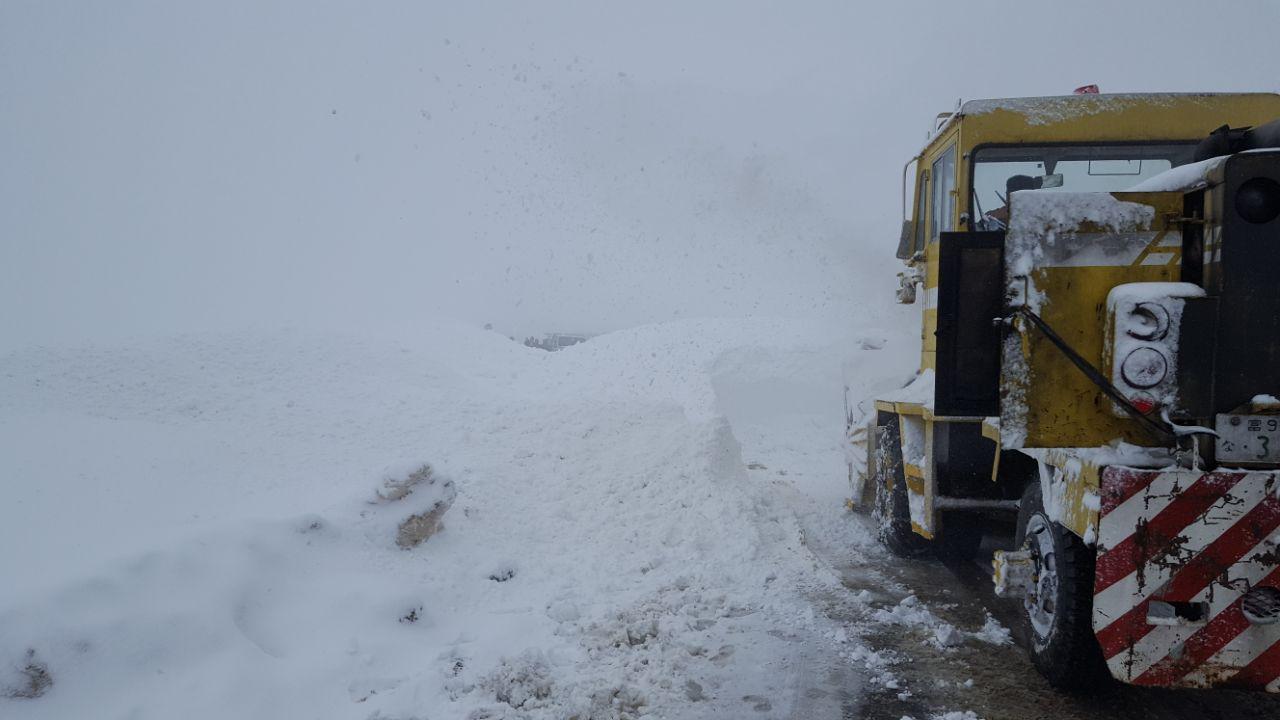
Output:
[970, 142, 1196, 229]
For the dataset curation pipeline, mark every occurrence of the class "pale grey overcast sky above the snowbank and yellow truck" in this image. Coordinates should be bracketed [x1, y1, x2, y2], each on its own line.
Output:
[0, 0, 1280, 348]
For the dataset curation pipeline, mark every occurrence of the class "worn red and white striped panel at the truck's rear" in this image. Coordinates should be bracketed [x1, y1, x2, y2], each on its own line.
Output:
[1093, 468, 1280, 692]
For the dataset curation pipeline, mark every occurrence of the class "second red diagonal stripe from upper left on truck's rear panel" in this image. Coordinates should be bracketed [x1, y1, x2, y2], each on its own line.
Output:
[1093, 473, 1244, 593]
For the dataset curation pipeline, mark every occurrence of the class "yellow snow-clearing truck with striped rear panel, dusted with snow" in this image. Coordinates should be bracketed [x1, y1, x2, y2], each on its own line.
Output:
[850, 94, 1280, 692]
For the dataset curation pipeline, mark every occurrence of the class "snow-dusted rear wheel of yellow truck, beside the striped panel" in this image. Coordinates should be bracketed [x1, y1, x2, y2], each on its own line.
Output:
[1016, 483, 1110, 692]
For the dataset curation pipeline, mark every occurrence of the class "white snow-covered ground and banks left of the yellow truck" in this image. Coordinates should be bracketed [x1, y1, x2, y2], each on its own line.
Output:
[0, 313, 914, 720]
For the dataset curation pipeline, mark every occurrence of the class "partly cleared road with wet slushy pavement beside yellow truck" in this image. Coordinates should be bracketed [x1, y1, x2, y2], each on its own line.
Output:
[718, 325, 1280, 720]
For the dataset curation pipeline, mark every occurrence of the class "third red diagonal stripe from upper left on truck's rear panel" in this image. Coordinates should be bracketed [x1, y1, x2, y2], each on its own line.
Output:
[1097, 496, 1280, 660]
